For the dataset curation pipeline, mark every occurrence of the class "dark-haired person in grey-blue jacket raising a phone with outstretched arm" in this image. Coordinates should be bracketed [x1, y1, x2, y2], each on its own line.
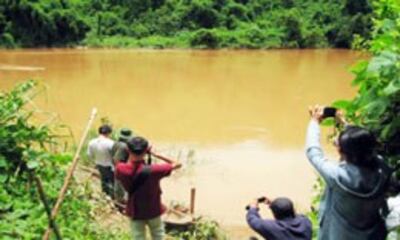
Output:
[306, 106, 390, 240]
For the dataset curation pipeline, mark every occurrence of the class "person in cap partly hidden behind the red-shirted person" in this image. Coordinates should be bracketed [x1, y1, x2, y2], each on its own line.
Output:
[111, 128, 133, 206]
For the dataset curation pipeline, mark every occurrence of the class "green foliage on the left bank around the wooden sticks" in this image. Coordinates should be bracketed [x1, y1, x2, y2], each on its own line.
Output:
[0, 81, 129, 240]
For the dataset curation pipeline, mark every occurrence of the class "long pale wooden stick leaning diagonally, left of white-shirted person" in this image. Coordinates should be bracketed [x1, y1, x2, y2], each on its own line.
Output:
[42, 108, 97, 240]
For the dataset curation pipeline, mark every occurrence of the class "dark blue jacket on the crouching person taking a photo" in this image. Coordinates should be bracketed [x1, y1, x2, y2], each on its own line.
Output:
[247, 208, 312, 240]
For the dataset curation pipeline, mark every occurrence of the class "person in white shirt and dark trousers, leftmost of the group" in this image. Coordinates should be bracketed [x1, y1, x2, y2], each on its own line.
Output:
[87, 125, 114, 198]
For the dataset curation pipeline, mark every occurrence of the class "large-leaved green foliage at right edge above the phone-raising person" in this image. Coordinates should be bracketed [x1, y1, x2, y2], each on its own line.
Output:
[335, 0, 400, 176]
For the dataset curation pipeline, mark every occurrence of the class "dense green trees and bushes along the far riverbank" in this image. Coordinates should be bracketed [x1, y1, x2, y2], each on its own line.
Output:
[0, 0, 372, 48]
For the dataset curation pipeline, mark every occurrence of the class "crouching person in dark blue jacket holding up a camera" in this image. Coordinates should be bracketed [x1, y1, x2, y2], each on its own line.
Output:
[246, 197, 312, 240]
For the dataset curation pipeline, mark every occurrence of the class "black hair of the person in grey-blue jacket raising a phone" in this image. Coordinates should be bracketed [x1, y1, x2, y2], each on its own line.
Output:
[339, 126, 378, 169]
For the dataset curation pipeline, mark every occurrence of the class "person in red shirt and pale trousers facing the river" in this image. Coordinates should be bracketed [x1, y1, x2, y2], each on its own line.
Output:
[115, 137, 182, 240]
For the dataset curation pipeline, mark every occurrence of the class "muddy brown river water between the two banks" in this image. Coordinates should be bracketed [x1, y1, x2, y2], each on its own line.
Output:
[0, 50, 360, 238]
